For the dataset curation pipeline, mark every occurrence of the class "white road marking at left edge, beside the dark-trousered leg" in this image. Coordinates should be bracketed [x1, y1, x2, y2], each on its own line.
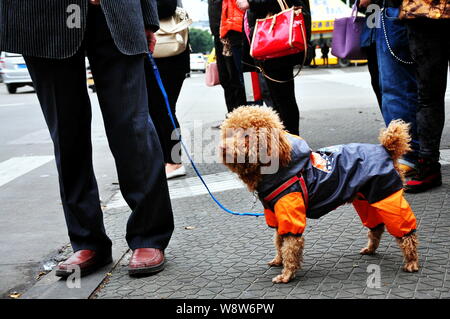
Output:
[0, 156, 54, 187]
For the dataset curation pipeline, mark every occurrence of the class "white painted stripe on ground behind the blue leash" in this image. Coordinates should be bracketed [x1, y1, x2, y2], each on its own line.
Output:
[106, 172, 245, 209]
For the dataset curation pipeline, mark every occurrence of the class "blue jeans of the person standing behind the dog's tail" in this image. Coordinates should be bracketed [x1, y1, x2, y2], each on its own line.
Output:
[375, 8, 419, 164]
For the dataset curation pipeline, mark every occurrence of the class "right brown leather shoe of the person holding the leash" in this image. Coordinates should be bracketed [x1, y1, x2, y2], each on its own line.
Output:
[128, 248, 165, 276]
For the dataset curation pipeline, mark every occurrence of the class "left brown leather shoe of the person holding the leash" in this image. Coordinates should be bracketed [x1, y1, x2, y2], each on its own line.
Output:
[55, 249, 112, 278]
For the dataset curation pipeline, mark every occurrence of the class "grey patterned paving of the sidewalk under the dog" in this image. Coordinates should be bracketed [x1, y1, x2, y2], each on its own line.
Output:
[92, 165, 450, 298]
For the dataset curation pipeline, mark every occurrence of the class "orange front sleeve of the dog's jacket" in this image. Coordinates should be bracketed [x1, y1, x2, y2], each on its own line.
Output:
[274, 192, 306, 236]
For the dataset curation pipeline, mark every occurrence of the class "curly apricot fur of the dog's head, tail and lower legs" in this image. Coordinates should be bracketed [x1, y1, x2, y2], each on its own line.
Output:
[220, 106, 418, 283]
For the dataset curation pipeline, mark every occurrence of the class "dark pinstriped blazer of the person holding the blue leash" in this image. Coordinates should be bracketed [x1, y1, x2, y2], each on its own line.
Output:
[0, 0, 159, 59]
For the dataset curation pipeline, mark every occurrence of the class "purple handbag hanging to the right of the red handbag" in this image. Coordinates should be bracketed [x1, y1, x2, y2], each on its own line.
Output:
[331, 2, 367, 60]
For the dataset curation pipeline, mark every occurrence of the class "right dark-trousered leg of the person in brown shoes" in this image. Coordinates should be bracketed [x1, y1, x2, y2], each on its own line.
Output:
[86, 4, 174, 250]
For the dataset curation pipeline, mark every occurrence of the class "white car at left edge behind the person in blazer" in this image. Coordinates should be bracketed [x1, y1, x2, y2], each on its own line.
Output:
[0, 52, 33, 94]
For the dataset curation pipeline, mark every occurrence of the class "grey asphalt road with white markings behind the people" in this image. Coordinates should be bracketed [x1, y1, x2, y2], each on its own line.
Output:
[0, 66, 450, 297]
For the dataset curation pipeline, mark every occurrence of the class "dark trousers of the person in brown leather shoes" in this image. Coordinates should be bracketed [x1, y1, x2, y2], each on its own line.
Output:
[25, 6, 174, 253]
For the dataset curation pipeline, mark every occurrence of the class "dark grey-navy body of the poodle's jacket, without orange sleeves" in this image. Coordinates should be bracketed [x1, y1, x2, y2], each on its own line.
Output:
[257, 135, 403, 219]
